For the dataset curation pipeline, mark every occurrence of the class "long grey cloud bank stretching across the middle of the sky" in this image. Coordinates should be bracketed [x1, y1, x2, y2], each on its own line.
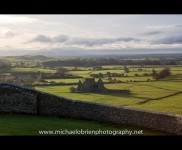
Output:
[30, 34, 140, 47]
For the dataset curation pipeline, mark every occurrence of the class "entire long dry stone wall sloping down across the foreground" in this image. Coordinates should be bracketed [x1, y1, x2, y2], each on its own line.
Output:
[0, 84, 182, 135]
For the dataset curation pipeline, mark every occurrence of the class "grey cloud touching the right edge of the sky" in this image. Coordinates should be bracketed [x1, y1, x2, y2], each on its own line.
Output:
[152, 35, 182, 44]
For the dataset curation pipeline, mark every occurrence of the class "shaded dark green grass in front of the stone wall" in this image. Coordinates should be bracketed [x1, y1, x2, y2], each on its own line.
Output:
[0, 114, 167, 136]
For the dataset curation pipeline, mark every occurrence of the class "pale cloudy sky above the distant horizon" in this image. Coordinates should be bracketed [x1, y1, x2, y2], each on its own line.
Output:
[0, 15, 182, 55]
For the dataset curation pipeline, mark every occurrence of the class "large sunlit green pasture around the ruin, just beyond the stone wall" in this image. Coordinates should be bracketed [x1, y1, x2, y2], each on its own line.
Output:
[36, 77, 182, 115]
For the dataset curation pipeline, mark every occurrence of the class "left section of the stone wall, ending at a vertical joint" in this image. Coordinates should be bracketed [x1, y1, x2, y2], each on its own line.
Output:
[0, 85, 37, 114]
